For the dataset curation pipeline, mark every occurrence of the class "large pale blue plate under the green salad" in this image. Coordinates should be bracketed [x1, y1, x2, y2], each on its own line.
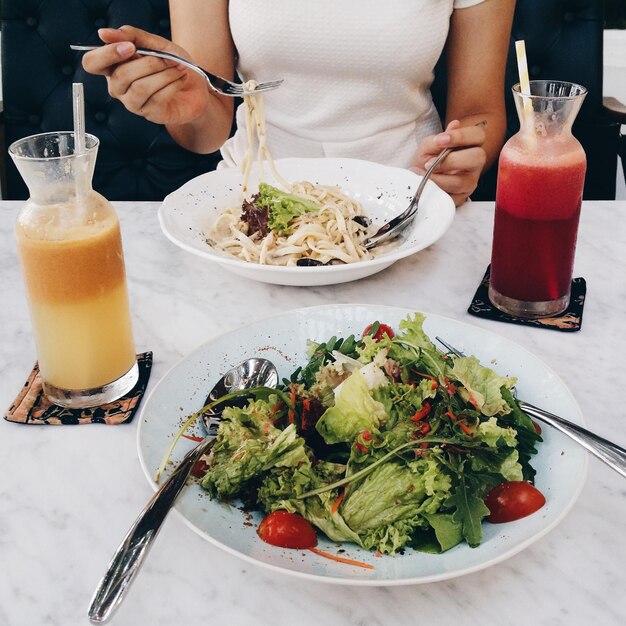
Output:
[137, 305, 587, 586]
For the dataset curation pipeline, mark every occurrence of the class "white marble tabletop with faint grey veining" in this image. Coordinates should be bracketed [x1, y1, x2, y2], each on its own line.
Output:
[0, 202, 626, 626]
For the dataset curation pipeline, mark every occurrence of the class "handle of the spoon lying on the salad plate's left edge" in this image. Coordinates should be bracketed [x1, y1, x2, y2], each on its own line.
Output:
[88, 438, 215, 624]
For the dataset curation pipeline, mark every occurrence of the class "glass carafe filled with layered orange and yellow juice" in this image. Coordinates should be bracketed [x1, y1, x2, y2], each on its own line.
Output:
[9, 131, 138, 408]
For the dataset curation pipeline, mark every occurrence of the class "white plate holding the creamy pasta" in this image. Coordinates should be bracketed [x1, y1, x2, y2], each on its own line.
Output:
[159, 158, 455, 286]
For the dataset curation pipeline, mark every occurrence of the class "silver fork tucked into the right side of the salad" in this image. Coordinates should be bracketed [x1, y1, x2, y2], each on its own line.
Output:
[435, 337, 626, 477]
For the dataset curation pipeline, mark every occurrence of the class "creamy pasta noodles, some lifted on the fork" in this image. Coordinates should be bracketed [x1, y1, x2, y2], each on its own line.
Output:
[207, 81, 371, 265]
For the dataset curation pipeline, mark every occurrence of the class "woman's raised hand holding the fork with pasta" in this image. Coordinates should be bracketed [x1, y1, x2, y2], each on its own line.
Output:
[83, 26, 215, 124]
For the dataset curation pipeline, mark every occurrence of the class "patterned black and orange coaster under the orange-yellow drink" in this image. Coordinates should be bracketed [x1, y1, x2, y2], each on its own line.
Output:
[4, 352, 152, 425]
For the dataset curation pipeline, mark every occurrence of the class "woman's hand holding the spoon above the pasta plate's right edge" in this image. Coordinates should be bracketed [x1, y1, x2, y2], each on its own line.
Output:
[410, 120, 487, 206]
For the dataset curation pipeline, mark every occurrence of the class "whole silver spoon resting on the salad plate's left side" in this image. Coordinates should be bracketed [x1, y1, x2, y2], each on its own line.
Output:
[88, 358, 278, 624]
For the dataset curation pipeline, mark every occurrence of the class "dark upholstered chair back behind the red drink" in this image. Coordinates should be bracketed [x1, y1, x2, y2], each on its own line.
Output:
[433, 0, 619, 200]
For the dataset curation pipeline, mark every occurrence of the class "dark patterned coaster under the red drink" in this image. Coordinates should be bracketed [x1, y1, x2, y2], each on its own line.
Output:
[467, 267, 587, 333]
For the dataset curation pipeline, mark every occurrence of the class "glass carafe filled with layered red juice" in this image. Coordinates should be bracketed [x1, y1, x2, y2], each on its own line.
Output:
[489, 81, 587, 318]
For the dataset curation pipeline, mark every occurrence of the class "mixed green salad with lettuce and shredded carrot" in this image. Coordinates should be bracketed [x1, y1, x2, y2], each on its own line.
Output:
[191, 313, 541, 554]
